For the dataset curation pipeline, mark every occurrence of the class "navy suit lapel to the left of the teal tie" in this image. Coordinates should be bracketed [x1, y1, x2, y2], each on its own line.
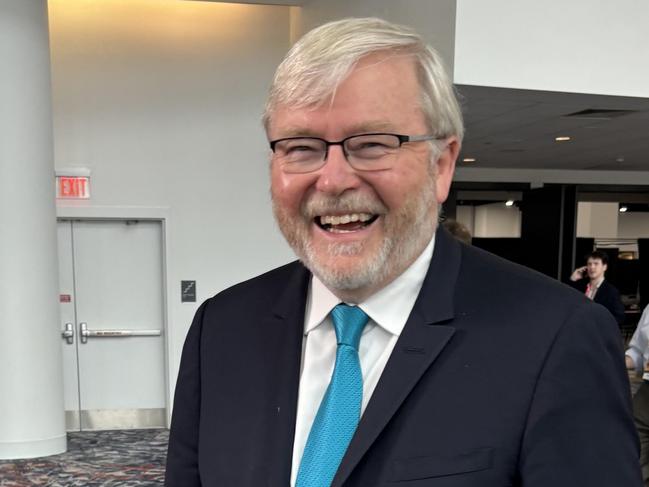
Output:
[260, 264, 311, 487]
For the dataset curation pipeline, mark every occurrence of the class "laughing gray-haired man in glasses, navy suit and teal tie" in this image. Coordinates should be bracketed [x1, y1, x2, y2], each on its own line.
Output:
[167, 19, 641, 487]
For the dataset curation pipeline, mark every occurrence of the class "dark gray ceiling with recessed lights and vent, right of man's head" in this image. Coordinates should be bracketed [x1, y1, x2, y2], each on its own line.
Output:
[457, 85, 649, 171]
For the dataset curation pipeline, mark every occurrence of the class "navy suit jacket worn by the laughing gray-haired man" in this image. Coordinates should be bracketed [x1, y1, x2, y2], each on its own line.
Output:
[166, 229, 642, 487]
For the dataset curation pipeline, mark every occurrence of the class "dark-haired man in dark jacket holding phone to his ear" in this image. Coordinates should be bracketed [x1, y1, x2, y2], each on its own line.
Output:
[570, 250, 625, 325]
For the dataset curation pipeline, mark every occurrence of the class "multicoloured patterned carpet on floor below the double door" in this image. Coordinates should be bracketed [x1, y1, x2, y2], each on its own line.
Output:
[0, 429, 169, 487]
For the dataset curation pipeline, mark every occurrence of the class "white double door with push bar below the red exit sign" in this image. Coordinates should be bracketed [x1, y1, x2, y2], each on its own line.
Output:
[58, 220, 166, 431]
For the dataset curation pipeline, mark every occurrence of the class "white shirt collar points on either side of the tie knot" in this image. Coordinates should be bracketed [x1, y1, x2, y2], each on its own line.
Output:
[304, 234, 435, 336]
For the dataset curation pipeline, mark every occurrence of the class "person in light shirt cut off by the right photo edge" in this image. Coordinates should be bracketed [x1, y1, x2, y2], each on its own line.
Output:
[624, 305, 649, 486]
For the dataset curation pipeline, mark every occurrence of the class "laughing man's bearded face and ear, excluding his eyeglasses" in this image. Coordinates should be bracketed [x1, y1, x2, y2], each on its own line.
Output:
[268, 53, 459, 300]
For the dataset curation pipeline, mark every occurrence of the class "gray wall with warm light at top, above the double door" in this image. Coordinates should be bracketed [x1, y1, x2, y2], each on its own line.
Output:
[49, 0, 293, 400]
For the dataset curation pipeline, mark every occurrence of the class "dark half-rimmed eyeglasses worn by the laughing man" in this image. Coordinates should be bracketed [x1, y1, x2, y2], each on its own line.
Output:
[270, 133, 443, 173]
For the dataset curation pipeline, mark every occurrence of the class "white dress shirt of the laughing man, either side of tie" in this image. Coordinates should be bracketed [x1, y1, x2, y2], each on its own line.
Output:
[291, 235, 435, 486]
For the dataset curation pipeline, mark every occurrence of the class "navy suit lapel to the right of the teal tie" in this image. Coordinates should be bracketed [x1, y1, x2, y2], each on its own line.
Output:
[331, 227, 461, 487]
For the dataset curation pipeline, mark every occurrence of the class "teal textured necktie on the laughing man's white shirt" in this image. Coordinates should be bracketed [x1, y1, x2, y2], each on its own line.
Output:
[295, 304, 368, 487]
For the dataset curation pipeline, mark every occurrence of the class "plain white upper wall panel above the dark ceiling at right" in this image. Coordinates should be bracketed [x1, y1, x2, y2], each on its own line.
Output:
[455, 0, 649, 98]
